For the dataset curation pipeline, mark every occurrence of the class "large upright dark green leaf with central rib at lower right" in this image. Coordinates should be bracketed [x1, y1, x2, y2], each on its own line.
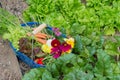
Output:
[94, 49, 113, 77]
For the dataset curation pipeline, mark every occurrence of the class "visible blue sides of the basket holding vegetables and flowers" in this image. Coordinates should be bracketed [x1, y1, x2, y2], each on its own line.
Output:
[10, 22, 66, 68]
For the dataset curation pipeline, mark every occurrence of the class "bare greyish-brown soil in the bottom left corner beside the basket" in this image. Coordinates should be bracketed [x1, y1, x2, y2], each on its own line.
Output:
[0, 38, 22, 80]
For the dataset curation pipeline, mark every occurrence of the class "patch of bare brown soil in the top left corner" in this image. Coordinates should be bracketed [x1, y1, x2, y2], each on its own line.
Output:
[0, 0, 27, 17]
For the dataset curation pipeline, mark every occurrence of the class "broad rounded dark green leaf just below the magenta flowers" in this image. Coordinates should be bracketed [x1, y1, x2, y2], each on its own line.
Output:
[56, 53, 77, 74]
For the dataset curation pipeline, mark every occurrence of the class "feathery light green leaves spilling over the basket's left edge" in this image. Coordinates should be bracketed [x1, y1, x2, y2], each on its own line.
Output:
[0, 8, 29, 49]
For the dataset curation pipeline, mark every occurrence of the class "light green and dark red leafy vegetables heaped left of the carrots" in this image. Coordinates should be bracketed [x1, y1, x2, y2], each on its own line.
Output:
[0, 9, 45, 63]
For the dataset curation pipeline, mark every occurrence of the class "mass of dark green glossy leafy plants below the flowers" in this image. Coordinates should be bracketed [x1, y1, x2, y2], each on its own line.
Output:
[23, 36, 120, 80]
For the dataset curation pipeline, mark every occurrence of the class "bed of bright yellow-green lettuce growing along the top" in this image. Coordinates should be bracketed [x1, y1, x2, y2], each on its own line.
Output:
[24, 0, 120, 35]
